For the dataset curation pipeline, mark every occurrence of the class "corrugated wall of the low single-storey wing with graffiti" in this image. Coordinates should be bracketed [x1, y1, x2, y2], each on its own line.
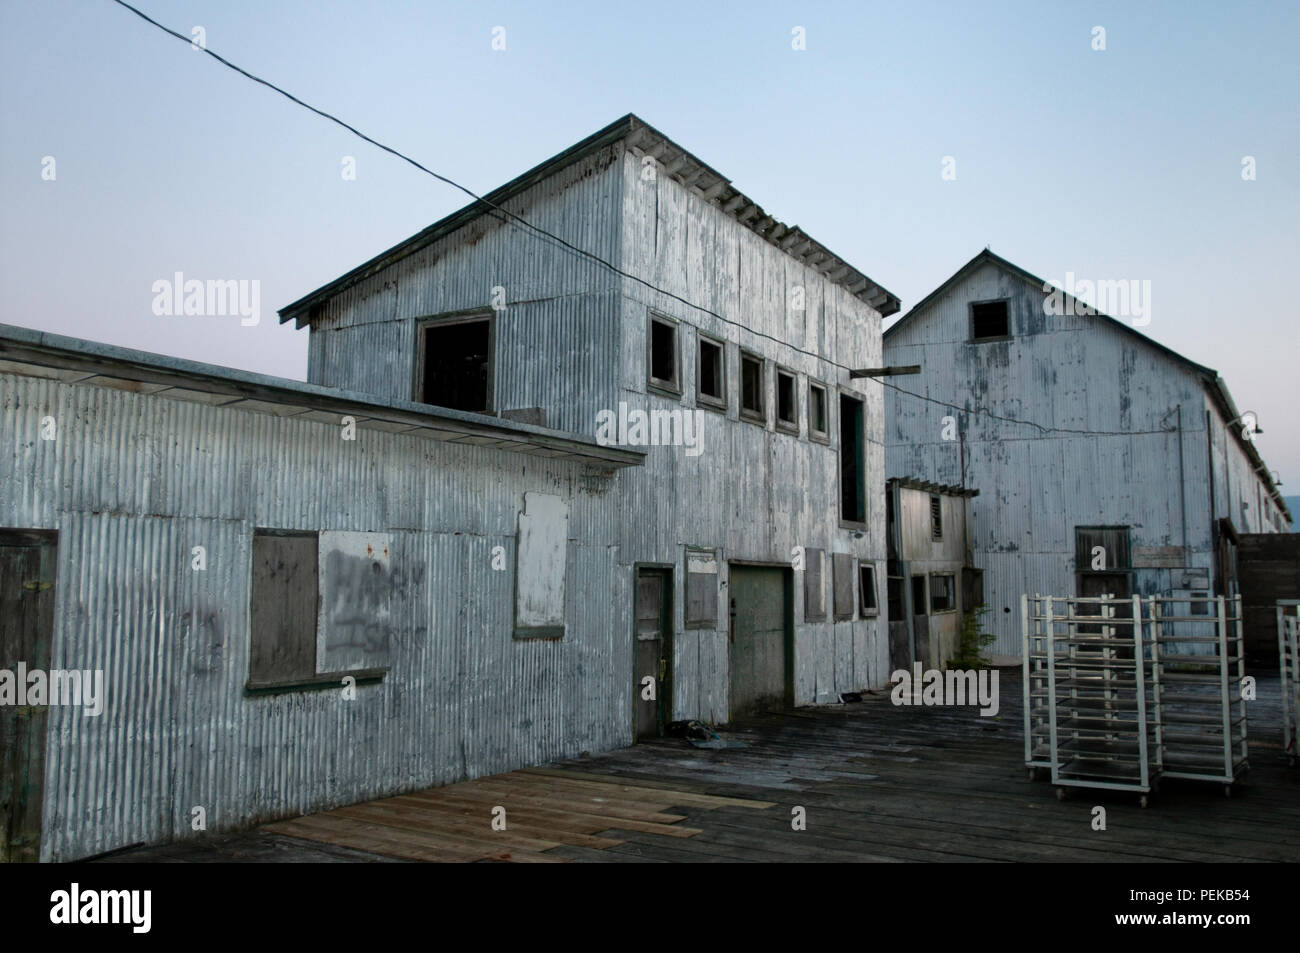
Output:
[0, 376, 632, 859]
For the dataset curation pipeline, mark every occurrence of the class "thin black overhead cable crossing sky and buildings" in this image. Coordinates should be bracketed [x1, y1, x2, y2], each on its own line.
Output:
[113, 0, 1190, 437]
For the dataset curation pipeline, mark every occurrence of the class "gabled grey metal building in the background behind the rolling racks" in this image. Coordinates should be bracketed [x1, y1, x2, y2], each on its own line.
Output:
[884, 250, 1292, 655]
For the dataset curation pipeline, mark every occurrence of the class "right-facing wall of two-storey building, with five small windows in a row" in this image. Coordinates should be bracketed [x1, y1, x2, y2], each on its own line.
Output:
[610, 153, 889, 722]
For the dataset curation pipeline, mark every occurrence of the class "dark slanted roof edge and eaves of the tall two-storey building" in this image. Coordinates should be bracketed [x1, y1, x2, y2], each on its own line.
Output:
[280, 113, 900, 328]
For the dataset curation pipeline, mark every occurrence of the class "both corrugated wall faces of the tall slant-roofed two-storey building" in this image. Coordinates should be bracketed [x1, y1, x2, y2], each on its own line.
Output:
[300, 137, 888, 723]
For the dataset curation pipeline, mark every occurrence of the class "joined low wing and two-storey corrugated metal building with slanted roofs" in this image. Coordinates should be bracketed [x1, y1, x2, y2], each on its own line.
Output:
[0, 116, 898, 859]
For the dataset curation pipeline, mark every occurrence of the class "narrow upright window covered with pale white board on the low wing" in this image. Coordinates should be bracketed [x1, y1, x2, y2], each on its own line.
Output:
[515, 493, 568, 638]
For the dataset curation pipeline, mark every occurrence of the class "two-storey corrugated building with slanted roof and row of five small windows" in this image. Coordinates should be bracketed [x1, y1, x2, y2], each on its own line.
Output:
[281, 116, 898, 731]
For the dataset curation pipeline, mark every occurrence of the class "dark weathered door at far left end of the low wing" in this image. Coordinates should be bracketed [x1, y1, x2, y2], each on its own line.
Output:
[0, 529, 55, 863]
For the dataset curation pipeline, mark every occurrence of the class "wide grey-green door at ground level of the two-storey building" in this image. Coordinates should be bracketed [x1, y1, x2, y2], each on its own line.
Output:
[728, 566, 794, 720]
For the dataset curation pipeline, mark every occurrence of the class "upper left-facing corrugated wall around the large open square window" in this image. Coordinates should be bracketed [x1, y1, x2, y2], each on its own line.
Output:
[308, 146, 621, 434]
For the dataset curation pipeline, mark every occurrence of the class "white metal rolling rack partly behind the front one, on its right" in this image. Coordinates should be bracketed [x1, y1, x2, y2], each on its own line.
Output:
[1145, 595, 1249, 794]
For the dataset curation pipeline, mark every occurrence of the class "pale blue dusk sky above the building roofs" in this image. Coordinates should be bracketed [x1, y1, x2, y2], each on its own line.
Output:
[0, 0, 1300, 483]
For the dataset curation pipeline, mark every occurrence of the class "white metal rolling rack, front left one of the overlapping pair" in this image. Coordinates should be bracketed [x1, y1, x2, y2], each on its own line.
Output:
[1043, 595, 1162, 807]
